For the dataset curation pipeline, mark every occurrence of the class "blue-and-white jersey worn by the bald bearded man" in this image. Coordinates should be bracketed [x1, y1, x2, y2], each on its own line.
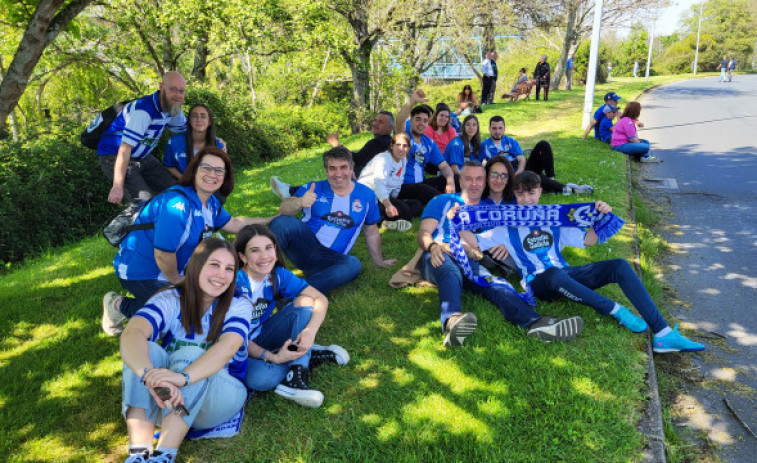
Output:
[97, 92, 187, 159]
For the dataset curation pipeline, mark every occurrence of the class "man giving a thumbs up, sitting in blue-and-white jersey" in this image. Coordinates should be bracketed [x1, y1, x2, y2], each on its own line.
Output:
[269, 146, 395, 294]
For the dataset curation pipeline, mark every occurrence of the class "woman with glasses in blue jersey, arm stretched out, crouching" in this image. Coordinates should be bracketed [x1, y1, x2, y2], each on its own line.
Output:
[102, 146, 271, 335]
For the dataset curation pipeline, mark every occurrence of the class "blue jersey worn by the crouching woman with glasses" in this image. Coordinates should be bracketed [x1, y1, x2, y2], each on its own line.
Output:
[113, 185, 231, 281]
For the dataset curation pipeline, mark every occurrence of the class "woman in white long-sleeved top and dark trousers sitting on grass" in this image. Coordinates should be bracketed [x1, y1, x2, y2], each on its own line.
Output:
[358, 133, 422, 231]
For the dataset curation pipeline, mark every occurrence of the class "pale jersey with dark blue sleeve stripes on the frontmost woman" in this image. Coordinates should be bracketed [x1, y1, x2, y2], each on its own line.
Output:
[134, 289, 250, 381]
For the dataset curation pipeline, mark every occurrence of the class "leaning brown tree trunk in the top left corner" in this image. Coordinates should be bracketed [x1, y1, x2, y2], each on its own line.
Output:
[0, 0, 92, 134]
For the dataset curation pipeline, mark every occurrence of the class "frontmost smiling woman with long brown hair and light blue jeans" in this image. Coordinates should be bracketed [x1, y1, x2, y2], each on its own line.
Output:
[121, 238, 250, 463]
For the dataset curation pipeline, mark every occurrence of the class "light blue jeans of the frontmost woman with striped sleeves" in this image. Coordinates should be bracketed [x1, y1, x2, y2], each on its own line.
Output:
[121, 342, 247, 429]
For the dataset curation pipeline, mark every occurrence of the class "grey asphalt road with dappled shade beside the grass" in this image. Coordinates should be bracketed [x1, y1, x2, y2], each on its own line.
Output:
[637, 76, 757, 462]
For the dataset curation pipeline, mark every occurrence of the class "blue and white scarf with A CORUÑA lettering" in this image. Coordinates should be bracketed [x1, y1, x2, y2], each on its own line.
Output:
[449, 203, 626, 305]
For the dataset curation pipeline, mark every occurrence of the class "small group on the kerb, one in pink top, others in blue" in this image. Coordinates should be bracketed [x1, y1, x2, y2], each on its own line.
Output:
[584, 92, 660, 163]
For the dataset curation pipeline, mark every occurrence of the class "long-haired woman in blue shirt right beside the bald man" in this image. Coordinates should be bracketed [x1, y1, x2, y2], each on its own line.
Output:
[163, 104, 226, 180]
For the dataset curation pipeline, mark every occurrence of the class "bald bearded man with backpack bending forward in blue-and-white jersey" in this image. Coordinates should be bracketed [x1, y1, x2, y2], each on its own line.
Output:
[97, 71, 187, 204]
